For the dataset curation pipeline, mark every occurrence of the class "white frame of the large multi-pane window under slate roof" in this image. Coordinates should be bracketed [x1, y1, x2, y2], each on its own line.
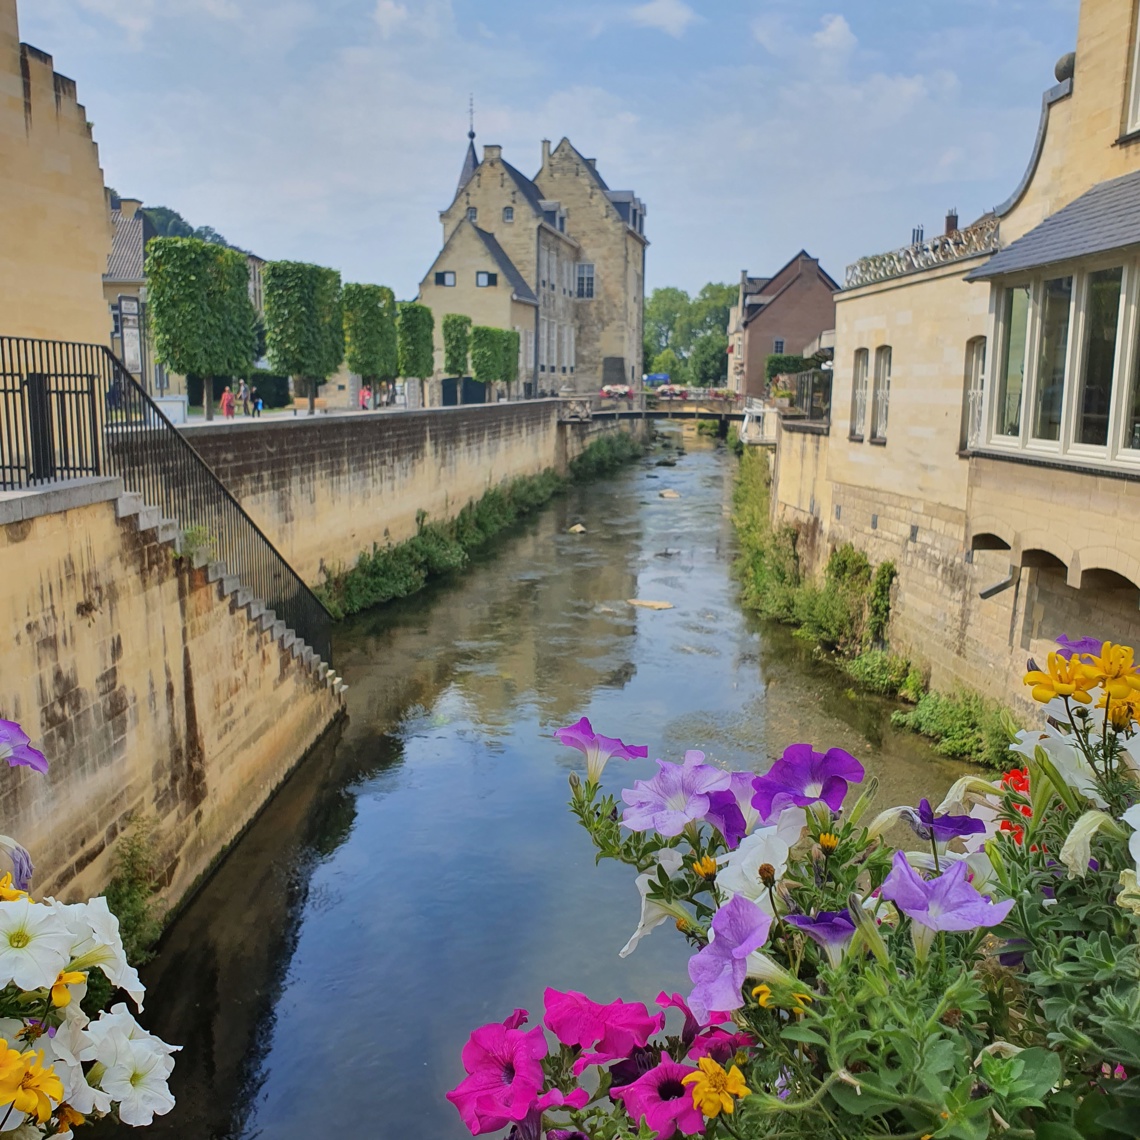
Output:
[979, 253, 1140, 473]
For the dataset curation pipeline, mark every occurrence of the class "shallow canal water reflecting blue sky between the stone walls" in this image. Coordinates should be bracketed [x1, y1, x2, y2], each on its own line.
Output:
[116, 434, 960, 1140]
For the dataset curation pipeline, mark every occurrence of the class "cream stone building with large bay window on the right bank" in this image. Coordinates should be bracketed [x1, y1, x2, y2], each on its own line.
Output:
[774, 0, 1140, 705]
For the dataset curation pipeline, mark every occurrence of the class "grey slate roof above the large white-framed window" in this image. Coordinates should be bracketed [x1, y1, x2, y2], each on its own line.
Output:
[966, 171, 1140, 282]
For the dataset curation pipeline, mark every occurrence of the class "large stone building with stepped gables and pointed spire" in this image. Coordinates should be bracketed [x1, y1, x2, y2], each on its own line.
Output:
[420, 132, 649, 392]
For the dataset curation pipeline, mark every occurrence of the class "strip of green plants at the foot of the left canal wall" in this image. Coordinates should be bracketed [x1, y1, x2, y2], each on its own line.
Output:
[316, 432, 644, 618]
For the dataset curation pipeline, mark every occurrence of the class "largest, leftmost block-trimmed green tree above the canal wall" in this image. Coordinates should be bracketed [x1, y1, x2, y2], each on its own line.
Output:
[145, 237, 257, 420]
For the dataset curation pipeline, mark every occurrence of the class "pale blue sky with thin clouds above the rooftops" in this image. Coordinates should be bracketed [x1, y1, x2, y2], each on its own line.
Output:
[18, 0, 1078, 298]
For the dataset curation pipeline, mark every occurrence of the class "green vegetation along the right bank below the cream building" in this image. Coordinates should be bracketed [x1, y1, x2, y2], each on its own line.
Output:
[733, 448, 1009, 768]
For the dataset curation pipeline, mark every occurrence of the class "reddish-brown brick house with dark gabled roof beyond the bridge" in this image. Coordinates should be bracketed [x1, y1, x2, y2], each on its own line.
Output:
[727, 256, 839, 396]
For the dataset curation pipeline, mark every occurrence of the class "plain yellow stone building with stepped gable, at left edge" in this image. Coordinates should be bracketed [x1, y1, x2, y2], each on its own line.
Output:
[0, 0, 111, 344]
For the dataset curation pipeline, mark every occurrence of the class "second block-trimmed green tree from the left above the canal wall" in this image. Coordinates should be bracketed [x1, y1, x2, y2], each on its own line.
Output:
[261, 261, 344, 416]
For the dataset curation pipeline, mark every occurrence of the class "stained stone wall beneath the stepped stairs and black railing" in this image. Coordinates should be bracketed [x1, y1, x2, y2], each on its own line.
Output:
[0, 479, 341, 902]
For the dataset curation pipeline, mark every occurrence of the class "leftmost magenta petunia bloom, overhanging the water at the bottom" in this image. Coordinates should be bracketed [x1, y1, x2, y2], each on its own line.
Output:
[447, 1010, 546, 1135]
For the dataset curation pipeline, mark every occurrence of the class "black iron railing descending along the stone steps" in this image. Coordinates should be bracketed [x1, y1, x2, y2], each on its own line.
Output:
[0, 336, 332, 662]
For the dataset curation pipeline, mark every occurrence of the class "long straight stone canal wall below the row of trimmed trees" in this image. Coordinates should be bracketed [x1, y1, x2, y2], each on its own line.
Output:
[185, 400, 645, 584]
